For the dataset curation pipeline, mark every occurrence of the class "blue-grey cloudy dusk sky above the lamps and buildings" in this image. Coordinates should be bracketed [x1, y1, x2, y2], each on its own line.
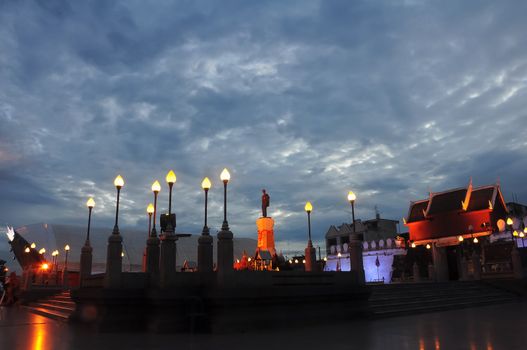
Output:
[0, 0, 527, 249]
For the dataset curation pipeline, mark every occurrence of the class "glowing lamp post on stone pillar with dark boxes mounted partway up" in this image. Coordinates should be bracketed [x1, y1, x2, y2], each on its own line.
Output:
[159, 170, 177, 286]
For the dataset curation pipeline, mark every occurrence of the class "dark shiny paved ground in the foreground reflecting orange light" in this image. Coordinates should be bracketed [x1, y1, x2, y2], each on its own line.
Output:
[0, 302, 527, 350]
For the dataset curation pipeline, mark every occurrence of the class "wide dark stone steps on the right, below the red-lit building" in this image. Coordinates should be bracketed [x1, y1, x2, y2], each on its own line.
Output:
[369, 282, 518, 317]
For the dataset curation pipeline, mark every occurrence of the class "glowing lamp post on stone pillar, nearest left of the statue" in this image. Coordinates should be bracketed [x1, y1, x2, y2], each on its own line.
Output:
[217, 168, 234, 278]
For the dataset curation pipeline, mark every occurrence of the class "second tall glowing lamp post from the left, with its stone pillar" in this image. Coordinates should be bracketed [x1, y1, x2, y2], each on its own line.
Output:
[104, 175, 124, 288]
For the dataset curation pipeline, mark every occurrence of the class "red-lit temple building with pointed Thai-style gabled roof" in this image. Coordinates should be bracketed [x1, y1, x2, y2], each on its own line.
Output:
[404, 180, 512, 281]
